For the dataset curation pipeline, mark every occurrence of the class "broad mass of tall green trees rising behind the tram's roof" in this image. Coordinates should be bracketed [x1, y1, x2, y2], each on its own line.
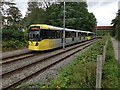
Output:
[21, 0, 96, 31]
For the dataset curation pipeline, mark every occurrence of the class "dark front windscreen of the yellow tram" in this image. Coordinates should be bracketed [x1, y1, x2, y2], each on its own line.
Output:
[29, 31, 40, 41]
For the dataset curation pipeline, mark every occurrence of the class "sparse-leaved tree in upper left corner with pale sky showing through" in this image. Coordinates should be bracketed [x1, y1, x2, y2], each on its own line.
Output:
[1, 0, 22, 28]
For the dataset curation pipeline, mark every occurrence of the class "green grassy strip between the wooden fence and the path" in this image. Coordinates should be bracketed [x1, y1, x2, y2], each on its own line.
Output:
[102, 40, 119, 88]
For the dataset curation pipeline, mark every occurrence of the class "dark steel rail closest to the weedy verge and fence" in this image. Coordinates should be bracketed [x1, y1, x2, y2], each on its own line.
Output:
[4, 42, 94, 89]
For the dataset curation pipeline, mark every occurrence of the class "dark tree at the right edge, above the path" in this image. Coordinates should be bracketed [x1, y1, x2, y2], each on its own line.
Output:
[112, 10, 120, 41]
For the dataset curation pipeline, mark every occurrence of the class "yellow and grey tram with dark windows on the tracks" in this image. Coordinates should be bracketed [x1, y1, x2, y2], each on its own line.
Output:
[28, 24, 93, 51]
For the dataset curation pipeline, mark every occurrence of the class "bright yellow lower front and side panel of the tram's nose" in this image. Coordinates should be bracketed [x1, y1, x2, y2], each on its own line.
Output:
[28, 39, 55, 51]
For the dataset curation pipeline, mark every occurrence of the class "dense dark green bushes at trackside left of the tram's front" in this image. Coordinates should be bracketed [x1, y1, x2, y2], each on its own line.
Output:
[2, 28, 27, 52]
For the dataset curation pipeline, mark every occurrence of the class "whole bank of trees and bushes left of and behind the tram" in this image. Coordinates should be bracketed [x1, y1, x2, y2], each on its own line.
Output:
[0, 0, 96, 51]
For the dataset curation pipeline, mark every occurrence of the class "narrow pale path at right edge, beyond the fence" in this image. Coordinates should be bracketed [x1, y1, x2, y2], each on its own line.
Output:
[111, 38, 120, 64]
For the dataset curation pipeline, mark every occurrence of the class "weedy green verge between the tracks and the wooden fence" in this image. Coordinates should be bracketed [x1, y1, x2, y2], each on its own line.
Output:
[19, 37, 107, 89]
